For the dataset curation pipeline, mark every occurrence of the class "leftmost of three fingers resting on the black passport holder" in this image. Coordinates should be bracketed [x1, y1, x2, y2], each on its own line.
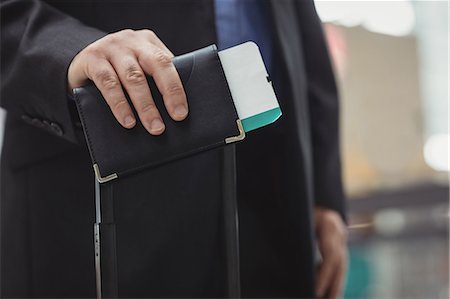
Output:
[86, 59, 136, 129]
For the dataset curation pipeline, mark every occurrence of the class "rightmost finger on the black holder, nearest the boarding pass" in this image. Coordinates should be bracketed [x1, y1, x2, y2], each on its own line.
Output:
[137, 45, 188, 121]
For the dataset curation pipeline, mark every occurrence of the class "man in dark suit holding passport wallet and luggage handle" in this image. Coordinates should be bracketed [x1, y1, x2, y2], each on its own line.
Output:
[1, 0, 346, 298]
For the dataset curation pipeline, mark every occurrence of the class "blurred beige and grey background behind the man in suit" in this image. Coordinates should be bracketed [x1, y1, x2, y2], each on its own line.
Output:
[0, 0, 450, 299]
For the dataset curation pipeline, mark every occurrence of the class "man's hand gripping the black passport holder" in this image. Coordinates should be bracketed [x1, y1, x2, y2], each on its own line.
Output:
[67, 29, 188, 135]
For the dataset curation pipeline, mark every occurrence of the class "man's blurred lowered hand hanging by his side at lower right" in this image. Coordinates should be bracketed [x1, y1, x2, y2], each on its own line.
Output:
[315, 207, 347, 299]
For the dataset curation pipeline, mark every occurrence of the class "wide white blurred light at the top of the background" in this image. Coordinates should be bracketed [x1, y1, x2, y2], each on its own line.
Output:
[315, 0, 415, 36]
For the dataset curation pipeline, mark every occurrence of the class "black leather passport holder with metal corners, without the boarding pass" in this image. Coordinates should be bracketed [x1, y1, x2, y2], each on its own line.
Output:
[74, 45, 245, 183]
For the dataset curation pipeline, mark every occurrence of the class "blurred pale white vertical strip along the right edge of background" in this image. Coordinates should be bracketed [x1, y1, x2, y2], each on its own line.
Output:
[413, 1, 450, 178]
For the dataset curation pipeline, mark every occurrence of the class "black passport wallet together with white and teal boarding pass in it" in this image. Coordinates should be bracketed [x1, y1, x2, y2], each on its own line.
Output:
[73, 42, 281, 183]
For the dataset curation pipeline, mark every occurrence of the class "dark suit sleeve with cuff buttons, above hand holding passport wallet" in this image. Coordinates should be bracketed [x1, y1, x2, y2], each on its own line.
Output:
[0, 0, 105, 142]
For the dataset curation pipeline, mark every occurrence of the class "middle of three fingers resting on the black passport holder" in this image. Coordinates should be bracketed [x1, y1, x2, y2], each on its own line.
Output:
[111, 53, 165, 135]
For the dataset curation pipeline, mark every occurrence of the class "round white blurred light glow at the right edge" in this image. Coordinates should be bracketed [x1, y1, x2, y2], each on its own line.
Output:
[423, 134, 450, 171]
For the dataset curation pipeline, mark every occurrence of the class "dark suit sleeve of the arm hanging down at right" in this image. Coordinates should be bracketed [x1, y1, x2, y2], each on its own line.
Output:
[297, 0, 346, 219]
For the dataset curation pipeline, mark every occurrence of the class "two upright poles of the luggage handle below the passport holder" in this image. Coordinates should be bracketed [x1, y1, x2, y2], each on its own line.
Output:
[94, 144, 241, 299]
